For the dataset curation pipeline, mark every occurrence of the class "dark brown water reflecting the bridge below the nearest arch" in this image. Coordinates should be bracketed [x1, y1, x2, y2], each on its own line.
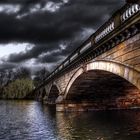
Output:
[57, 110, 140, 140]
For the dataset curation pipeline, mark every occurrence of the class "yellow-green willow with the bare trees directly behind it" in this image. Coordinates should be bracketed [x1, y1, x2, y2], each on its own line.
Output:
[0, 67, 34, 99]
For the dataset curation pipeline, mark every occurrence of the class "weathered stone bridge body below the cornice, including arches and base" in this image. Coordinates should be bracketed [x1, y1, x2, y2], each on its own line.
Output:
[39, 34, 140, 111]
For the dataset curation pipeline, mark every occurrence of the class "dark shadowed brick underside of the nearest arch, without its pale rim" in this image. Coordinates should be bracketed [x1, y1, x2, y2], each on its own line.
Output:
[65, 70, 140, 109]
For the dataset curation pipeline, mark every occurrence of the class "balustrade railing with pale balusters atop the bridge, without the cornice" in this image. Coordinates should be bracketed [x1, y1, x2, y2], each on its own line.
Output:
[45, 4, 140, 81]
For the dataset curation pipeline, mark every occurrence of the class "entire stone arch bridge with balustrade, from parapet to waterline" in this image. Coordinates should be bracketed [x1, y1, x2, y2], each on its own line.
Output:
[35, 4, 140, 111]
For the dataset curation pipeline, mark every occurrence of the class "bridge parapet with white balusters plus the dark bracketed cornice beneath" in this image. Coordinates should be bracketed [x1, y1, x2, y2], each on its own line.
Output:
[40, 4, 140, 89]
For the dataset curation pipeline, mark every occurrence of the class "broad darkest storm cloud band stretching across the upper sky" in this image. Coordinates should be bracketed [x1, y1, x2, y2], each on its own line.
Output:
[0, 0, 124, 43]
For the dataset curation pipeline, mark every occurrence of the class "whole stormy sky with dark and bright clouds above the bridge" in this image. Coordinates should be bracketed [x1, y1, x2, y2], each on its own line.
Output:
[0, 0, 125, 71]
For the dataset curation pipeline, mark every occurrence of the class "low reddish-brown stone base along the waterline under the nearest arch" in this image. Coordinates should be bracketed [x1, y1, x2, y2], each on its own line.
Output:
[56, 98, 140, 112]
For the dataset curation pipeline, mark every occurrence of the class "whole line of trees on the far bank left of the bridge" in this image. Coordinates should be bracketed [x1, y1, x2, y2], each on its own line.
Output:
[0, 67, 48, 99]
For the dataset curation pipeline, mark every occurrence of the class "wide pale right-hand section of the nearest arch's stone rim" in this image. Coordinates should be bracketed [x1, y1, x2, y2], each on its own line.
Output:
[87, 60, 140, 90]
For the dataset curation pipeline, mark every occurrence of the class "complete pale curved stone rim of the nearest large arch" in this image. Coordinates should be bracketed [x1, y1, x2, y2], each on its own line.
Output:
[64, 60, 140, 98]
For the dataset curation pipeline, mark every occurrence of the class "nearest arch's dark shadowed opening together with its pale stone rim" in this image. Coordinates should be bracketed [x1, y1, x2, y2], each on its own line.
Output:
[65, 61, 140, 108]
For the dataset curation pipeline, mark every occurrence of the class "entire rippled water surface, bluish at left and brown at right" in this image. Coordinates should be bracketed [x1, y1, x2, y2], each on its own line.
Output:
[0, 101, 140, 140]
